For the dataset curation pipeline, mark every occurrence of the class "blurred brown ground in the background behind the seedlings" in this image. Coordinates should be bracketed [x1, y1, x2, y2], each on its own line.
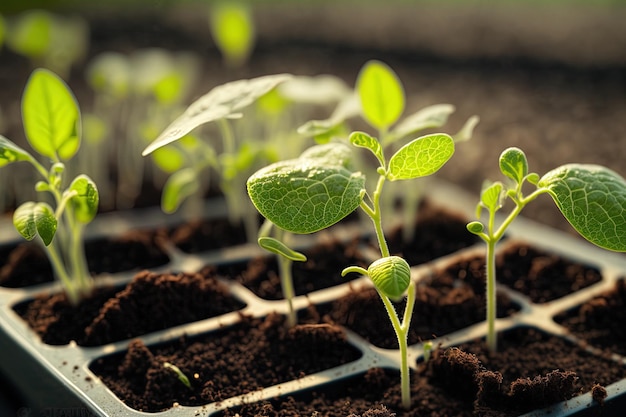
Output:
[0, 1, 626, 237]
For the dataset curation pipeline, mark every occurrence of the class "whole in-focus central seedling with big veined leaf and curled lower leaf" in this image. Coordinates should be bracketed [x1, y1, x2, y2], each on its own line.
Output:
[247, 127, 454, 408]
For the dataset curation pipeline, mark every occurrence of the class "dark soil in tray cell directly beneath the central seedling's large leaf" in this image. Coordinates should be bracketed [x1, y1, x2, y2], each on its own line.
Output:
[218, 234, 371, 300]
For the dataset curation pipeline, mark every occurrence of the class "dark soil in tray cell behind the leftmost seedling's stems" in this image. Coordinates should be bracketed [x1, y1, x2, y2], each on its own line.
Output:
[0, 230, 169, 288]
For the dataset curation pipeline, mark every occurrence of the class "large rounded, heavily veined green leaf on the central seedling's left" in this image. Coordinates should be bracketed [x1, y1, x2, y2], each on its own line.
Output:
[247, 143, 365, 233]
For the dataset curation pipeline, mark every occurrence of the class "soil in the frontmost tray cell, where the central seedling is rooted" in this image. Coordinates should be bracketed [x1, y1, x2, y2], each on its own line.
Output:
[220, 328, 626, 417]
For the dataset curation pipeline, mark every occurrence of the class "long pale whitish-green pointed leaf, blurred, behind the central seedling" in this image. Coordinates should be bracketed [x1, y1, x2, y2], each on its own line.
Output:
[142, 74, 292, 156]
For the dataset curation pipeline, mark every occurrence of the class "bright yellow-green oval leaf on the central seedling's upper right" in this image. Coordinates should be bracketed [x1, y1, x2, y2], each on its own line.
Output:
[387, 133, 454, 181]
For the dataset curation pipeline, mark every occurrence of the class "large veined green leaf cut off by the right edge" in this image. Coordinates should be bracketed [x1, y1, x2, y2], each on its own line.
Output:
[538, 164, 626, 252]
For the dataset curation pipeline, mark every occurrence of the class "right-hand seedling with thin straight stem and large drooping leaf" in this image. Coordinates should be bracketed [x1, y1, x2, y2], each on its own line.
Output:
[467, 148, 626, 351]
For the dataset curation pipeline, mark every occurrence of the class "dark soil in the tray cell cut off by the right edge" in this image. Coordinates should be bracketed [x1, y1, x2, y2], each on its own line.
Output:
[554, 279, 626, 356]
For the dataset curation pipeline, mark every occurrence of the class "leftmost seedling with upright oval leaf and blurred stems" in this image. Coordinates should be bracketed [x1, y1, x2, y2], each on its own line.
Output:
[0, 69, 99, 304]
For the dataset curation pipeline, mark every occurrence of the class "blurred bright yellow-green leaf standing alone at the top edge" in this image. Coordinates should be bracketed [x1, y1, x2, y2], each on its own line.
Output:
[210, 1, 255, 67]
